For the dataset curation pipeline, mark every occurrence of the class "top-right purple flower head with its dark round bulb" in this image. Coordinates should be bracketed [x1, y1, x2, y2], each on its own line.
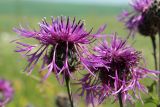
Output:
[119, 0, 160, 36]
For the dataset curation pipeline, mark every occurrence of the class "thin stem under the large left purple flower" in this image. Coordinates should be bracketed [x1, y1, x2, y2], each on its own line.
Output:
[65, 76, 74, 107]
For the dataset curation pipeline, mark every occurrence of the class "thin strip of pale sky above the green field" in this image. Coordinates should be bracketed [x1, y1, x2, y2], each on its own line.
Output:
[32, 0, 131, 4]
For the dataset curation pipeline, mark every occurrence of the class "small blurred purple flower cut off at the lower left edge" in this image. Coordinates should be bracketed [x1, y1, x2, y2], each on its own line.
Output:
[0, 79, 13, 107]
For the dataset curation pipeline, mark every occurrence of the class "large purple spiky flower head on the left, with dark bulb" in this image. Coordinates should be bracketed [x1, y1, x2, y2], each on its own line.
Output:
[14, 16, 105, 82]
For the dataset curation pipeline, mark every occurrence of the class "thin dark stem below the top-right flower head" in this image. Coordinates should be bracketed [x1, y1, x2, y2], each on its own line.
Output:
[151, 36, 158, 70]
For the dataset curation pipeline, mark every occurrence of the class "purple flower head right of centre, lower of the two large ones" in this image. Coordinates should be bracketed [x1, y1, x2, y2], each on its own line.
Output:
[78, 34, 159, 107]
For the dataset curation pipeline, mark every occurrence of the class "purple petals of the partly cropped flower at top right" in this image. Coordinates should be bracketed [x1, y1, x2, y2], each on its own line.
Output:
[119, 0, 153, 36]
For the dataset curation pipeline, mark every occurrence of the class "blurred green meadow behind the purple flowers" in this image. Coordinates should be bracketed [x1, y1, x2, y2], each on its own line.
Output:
[0, 0, 158, 107]
